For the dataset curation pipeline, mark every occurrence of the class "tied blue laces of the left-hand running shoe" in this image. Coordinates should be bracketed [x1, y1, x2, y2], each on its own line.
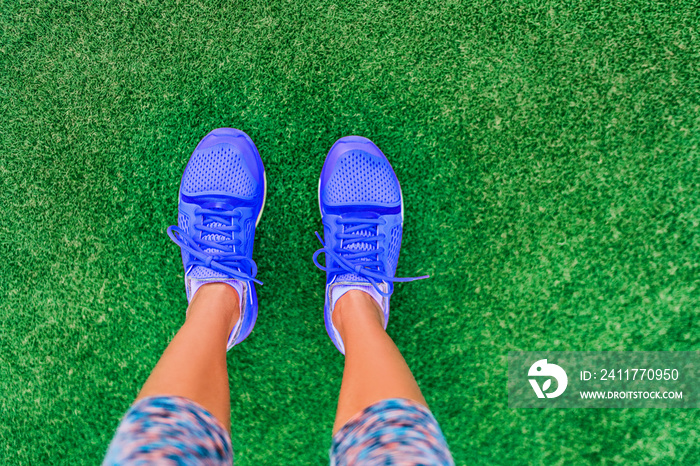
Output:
[168, 208, 262, 285]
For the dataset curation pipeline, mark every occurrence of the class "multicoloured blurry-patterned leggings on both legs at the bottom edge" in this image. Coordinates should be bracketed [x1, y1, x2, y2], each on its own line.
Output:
[103, 396, 454, 466]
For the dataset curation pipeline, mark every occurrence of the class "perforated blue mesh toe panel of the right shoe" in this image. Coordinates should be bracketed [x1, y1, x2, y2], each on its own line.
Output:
[325, 151, 401, 204]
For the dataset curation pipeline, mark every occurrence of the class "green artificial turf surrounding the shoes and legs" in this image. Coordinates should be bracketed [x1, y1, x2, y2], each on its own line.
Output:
[0, 0, 700, 465]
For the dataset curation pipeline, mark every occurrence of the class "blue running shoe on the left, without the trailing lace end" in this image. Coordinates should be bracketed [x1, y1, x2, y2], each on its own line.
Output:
[168, 128, 266, 349]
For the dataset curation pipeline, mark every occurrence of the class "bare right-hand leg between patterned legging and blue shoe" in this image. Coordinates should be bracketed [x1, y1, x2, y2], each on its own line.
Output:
[333, 290, 427, 433]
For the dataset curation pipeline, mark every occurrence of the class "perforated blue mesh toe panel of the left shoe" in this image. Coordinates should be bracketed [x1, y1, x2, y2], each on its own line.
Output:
[182, 144, 256, 197]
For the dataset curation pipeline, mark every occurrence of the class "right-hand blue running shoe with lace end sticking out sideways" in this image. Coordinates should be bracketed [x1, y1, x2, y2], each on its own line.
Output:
[313, 136, 428, 354]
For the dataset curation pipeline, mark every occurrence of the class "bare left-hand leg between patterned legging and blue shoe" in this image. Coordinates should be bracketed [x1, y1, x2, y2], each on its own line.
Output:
[136, 283, 240, 430]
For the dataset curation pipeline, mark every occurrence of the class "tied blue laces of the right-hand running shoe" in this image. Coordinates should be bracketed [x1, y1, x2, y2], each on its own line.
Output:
[313, 218, 429, 297]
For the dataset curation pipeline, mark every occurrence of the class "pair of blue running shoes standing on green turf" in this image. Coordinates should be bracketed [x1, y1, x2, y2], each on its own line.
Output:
[168, 128, 427, 354]
